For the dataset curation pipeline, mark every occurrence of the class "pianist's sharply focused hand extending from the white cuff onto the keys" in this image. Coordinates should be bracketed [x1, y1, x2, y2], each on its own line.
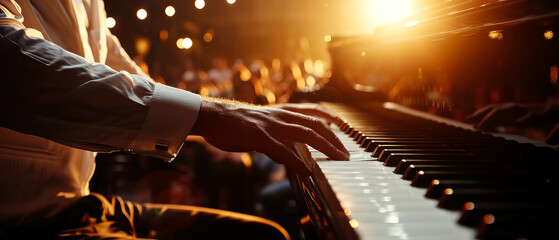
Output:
[191, 99, 349, 175]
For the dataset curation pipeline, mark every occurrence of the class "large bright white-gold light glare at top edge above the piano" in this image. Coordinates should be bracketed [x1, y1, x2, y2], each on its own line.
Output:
[372, 0, 411, 24]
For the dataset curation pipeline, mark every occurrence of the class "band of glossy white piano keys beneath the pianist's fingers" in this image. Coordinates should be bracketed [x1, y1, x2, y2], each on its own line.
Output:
[304, 126, 475, 240]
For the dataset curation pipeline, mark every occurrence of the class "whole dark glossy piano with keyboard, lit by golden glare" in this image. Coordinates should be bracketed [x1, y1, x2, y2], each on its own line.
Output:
[289, 0, 559, 240]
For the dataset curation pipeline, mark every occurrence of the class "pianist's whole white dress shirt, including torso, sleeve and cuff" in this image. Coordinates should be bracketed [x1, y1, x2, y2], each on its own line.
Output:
[0, 0, 201, 229]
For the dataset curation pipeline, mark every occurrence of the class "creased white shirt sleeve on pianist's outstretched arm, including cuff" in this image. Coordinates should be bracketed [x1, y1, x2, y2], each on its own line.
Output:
[0, 4, 201, 160]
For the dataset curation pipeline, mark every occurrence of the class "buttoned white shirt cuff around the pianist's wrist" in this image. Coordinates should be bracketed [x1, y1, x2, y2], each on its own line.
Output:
[131, 83, 202, 161]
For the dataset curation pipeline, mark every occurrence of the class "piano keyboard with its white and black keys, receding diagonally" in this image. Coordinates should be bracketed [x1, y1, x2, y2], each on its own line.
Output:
[295, 103, 559, 240]
